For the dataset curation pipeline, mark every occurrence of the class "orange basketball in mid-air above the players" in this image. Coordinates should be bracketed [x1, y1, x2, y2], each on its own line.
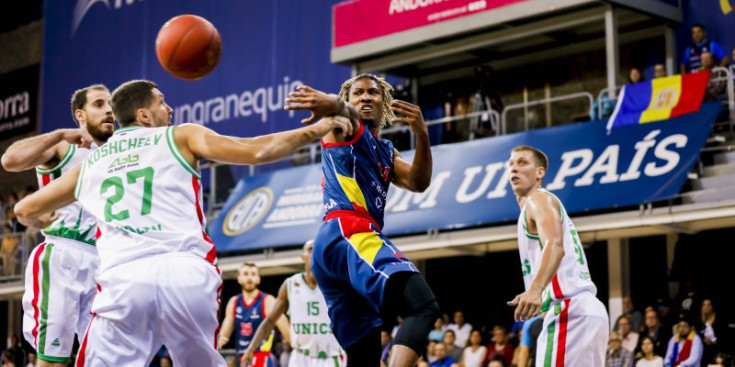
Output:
[156, 14, 222, 80]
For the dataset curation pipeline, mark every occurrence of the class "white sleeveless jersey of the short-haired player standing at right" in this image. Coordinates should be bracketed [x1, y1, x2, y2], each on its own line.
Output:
[518, 189, 597, 311]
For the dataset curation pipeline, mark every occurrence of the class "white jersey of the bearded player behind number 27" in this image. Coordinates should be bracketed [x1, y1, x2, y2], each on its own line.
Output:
[36, 144, 97, 246]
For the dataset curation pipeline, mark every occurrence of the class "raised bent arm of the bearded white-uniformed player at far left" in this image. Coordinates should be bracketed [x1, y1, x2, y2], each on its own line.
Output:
[2, 129, 92, 172]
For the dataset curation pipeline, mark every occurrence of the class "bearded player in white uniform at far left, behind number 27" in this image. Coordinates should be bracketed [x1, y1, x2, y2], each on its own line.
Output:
[2, 84, 115, 367]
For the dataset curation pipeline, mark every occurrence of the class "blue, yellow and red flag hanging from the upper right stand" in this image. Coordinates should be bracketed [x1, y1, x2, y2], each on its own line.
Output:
[607, 71, 710, 134]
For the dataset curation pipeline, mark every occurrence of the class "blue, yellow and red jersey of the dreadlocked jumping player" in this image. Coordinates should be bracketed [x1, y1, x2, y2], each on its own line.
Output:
[322, 123, 394, 228]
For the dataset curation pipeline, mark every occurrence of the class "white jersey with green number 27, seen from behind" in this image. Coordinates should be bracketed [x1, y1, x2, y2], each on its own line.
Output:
[75, 126, 216, 273]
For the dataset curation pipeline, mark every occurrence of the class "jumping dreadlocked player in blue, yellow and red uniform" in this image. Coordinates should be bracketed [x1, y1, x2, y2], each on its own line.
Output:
[286, 74, 439, 367]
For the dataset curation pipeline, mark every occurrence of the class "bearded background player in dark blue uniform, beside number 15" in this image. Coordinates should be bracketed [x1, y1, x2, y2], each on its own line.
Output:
[219, 262, 289, 367]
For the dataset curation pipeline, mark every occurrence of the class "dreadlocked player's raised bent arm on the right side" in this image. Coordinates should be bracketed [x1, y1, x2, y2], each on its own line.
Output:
[391, 100, 433, 192]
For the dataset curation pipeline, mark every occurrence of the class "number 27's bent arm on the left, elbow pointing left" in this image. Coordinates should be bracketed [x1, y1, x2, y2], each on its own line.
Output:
[15, 162, 84, 228]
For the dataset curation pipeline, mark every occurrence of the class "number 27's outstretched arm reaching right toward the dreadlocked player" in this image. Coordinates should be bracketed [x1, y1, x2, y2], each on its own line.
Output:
[174, 118, 352, 167]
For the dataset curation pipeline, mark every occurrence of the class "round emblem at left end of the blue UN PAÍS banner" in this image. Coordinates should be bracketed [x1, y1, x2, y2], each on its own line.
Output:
[222, 186, 273, 236]
